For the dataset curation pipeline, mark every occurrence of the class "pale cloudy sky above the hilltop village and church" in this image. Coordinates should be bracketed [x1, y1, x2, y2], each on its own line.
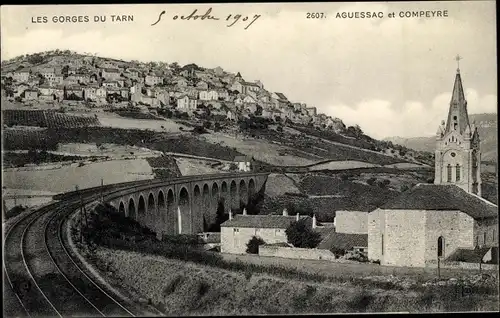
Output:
[0, 1, 497, 139]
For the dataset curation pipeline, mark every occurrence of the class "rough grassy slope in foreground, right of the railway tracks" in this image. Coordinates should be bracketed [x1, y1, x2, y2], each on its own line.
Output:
[88, 248, 498, 316]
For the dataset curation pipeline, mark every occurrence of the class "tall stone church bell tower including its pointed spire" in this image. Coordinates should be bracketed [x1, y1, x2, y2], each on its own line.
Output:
[434, 56, 481, 196]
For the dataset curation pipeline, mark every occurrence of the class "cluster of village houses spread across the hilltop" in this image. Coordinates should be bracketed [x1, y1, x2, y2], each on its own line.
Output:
[2, 59, 345, 130]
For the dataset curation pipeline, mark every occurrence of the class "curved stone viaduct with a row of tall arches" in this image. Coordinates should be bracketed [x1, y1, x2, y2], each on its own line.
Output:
[104, 172, 269, 235]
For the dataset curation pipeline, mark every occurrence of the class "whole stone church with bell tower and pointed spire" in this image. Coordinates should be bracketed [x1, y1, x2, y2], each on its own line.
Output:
[368, 60, 498, 267]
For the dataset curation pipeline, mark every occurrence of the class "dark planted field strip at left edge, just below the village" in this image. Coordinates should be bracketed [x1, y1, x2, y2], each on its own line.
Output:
[2, 109, 100, 128]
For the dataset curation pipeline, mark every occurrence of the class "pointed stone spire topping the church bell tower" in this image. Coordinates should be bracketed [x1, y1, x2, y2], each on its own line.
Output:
[445, 68, 470, 134]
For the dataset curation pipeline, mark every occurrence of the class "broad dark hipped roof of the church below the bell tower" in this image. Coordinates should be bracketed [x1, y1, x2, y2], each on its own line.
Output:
[380, 184, 498, 219]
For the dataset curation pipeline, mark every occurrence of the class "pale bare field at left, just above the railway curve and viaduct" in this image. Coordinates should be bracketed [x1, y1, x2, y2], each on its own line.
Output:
[3, 159, 153, 193]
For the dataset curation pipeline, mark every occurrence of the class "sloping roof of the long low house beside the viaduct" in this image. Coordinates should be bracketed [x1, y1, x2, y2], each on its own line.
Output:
[221, 214, 311, 229]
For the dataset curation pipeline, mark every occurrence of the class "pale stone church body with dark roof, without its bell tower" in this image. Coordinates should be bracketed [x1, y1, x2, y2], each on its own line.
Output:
[368, 184, 498, 267]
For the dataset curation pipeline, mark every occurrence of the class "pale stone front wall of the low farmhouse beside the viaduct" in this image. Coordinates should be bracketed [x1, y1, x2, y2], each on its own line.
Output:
[221, 227, 287, 254]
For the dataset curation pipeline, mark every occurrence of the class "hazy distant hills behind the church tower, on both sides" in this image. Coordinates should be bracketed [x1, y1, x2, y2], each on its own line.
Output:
[384, 114, 498, 161]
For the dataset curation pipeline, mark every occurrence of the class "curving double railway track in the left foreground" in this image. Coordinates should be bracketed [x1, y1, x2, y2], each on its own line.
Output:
[3, 185, 143, 317]
